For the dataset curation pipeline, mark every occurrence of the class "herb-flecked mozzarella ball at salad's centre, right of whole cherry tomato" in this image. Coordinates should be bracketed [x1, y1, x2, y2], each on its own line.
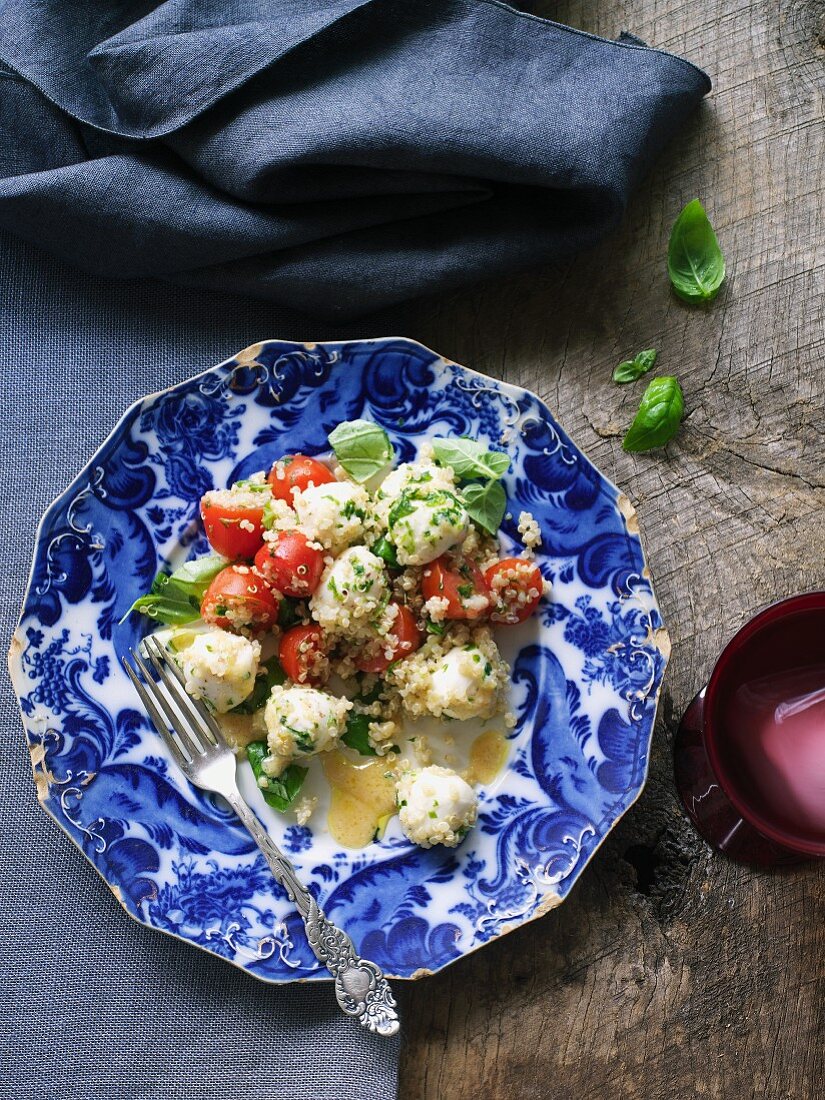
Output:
[309, 547, 389, 636]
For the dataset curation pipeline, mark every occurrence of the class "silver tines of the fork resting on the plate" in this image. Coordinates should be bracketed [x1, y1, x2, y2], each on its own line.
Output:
[121, 635, 223, 768]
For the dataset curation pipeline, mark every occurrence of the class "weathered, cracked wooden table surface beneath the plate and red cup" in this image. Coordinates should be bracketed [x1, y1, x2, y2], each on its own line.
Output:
[391, 0, 825, 1100]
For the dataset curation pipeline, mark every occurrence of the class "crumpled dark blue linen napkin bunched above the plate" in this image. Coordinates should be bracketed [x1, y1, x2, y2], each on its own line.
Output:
[0, 0, 711, 318]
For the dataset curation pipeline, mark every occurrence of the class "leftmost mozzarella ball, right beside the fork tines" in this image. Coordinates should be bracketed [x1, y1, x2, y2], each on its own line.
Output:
[178, 629, 261, 714]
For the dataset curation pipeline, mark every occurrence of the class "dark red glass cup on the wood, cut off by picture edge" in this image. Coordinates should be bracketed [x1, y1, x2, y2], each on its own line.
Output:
[674, 592, 825, 866]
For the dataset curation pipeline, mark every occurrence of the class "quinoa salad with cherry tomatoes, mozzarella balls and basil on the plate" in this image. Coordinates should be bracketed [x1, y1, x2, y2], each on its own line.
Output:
[130, 420, 550, 848]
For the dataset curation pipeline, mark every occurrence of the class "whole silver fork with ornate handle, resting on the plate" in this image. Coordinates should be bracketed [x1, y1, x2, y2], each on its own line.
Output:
[122, 636, 398, 1035]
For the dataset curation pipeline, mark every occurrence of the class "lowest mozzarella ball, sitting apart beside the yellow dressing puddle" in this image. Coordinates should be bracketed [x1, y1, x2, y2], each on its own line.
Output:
[396, 765, 479, 848]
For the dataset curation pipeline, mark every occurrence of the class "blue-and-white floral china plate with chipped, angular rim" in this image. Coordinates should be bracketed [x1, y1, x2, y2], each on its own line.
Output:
[10, 339, 669, 982]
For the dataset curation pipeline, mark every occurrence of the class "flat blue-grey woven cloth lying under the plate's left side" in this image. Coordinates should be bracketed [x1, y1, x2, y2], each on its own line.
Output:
[0, 225, 398, 1100]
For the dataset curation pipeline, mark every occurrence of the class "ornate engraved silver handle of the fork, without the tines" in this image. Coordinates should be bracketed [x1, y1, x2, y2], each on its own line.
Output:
[227, 791, 398, 1035]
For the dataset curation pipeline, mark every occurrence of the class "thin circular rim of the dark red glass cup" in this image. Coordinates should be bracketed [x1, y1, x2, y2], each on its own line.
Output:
[703, 590, 825, 856]
